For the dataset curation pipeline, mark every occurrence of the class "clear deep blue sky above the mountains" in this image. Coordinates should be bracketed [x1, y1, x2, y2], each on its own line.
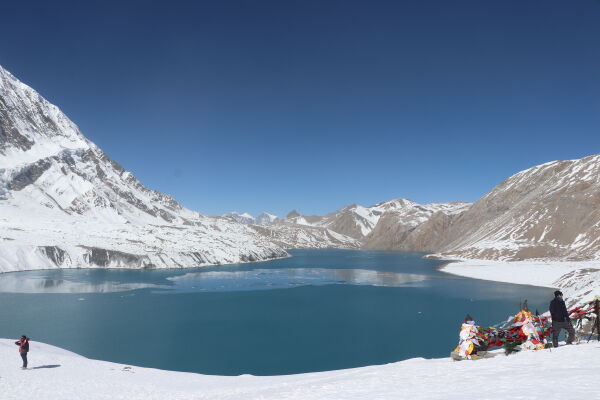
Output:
[0, 0, 600, 215]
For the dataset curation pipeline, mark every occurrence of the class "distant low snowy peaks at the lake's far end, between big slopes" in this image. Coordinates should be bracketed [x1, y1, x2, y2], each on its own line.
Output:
[218, 199, 471, 251]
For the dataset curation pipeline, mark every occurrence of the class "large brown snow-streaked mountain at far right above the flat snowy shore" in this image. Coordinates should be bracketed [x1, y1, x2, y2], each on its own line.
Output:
[439, 155, 600, 260]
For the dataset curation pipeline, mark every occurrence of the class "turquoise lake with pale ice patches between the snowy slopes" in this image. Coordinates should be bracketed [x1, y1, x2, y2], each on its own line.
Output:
[0, 250, 552, 375]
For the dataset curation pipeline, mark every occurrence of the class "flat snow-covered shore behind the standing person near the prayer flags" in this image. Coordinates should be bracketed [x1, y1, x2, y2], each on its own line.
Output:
[441, 260, 600, 304]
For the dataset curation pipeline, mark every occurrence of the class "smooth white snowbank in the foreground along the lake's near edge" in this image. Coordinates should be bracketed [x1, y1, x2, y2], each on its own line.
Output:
[0, 339, 600, 400]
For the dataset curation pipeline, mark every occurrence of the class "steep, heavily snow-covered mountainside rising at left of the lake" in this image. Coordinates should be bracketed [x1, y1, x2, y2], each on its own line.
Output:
[0, 67, 286, 272]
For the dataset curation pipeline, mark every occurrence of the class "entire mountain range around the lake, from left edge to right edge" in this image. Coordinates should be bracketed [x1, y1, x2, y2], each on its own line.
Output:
[0, 67, 600, 272]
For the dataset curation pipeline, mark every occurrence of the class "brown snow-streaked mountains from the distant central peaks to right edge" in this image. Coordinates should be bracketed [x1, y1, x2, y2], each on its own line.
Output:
[224, 159, 600, 260]
